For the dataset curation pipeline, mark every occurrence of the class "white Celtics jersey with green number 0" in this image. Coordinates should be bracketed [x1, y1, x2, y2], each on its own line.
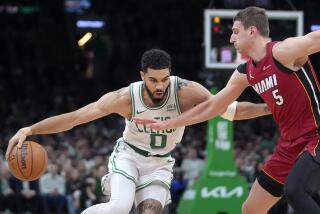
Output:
[123, 76, 184, 155]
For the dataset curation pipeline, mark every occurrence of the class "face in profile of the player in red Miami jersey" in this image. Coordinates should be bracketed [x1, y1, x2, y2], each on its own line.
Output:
[230, 21, 253, 54]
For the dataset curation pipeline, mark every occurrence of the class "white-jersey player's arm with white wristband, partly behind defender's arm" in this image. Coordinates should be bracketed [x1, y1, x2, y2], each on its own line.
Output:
[178, 78, 271, 121]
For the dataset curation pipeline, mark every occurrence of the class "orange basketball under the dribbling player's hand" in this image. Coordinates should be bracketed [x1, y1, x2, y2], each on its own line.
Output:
[8, 141, 48, 181]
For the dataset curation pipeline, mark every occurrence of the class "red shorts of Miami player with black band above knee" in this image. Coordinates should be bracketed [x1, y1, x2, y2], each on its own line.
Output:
[258, 135, 320, 197]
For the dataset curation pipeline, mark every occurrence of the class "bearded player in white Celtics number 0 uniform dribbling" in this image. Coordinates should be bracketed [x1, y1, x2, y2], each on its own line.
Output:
[6, 49, 270, 214]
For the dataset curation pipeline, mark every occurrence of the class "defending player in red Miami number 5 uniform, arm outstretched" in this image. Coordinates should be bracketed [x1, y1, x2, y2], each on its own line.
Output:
[137, 7, 320, 214]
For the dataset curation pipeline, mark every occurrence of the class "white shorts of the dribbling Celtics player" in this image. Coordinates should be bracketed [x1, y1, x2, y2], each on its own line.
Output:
[101, 138, 175, 206]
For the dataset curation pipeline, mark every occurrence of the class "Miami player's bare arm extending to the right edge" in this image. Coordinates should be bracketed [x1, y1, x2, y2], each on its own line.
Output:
[272, 30, 320, 70]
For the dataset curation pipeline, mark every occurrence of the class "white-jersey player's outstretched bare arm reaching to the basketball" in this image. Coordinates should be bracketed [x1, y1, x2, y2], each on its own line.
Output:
[6, 87, 131, 157]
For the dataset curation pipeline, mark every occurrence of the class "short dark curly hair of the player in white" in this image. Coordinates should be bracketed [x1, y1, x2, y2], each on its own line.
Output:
[141, 49, 171, 73]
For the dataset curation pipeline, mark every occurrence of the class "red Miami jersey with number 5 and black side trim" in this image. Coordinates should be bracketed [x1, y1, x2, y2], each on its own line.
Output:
[237, 42, 320, 141]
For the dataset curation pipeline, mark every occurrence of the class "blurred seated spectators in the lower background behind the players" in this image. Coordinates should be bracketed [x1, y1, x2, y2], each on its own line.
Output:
[0, 105, 280, 214]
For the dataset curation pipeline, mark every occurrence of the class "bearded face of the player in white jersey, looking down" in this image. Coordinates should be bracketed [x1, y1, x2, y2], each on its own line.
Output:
[140, 68, 170, 103]
